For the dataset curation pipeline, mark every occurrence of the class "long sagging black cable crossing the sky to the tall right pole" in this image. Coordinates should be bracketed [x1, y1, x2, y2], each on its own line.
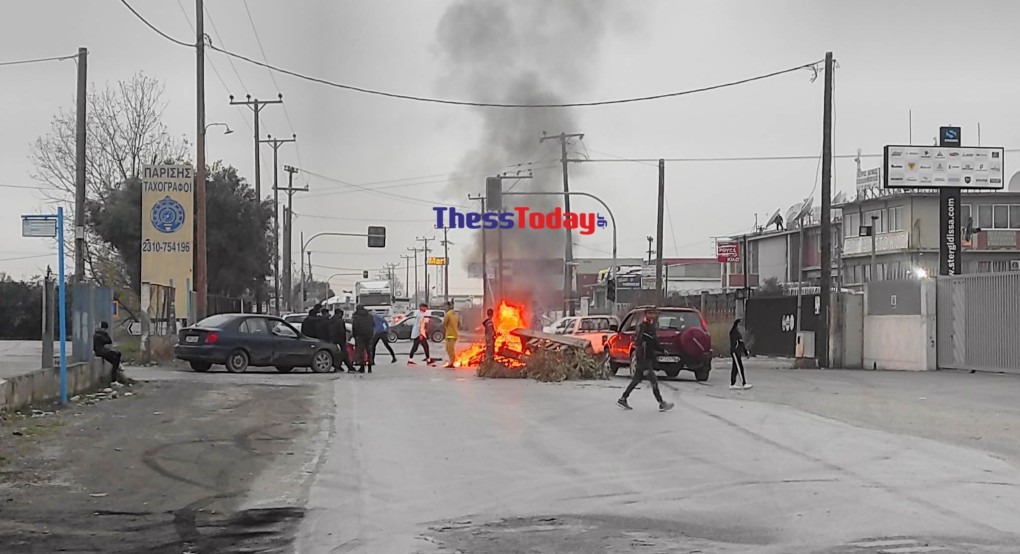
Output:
[120, 0, 822, 108]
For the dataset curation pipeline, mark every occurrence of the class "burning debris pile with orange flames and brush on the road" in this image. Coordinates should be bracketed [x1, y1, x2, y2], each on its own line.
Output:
[454, 300, 609, 383]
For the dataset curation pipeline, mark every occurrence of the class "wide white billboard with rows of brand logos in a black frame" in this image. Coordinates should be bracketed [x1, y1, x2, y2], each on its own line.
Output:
[882, 144, 1006, 190]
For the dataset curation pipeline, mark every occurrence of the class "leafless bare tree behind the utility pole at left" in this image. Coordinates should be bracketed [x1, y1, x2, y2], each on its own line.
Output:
[30, 71, 190, 286]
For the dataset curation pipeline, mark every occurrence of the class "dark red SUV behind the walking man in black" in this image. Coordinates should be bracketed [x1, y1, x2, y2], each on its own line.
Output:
[606, 307, 712, 381]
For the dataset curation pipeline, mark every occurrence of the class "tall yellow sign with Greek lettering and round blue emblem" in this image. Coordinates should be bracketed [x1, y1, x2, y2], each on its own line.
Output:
[142, 164, 195, 318]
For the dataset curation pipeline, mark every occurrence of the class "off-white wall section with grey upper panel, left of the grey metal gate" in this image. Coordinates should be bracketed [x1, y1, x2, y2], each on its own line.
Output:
[864, 281, 936, 371]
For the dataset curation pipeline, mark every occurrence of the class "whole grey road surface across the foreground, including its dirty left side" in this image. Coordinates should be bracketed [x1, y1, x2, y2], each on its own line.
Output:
[0, 343, 1020, 554]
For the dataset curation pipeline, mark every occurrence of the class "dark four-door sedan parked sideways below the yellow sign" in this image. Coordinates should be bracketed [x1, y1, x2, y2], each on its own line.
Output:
[173, 313, 340, 373]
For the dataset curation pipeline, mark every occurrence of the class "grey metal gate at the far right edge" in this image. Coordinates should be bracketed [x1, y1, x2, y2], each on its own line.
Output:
[935, 272, 1020, 373]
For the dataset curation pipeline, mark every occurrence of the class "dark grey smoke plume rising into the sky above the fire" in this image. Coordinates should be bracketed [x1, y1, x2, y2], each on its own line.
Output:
[438, 0, 613, 301]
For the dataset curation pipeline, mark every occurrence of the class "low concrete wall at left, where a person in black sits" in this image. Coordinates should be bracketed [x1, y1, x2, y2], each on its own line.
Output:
[0, 359, 112, 413]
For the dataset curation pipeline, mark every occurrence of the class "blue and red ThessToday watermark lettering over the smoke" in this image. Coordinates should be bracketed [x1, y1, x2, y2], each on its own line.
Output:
[432, 206, 609, 235]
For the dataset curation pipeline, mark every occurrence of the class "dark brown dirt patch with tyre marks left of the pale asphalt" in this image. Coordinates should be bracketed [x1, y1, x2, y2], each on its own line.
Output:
[0, 382, 321, 554]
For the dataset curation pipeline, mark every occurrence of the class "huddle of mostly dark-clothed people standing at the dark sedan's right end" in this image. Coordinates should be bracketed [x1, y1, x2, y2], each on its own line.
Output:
[301, 304, 397, 373]
